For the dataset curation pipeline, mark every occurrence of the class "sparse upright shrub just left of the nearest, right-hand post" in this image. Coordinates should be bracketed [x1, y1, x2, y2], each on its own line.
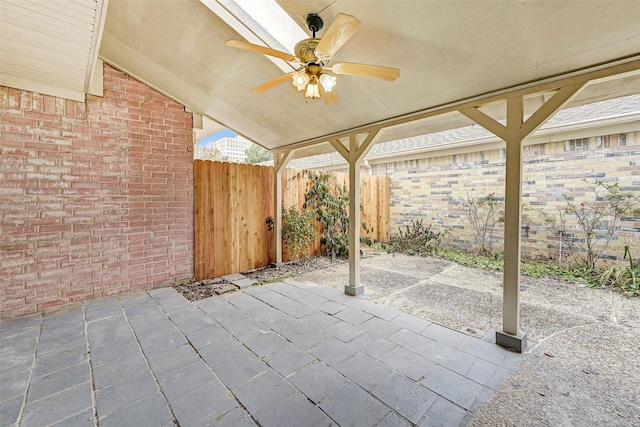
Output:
[449, 189, 504, 254]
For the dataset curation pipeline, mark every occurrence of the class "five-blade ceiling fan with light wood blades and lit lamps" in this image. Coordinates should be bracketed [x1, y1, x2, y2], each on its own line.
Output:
[225, 13, 400, 105]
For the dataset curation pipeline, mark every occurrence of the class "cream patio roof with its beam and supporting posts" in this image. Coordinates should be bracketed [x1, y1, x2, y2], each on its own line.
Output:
[0, 0, 640, 350]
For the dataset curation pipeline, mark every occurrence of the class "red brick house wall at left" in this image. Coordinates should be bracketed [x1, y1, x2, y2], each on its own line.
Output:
[0, 66, 194, 317]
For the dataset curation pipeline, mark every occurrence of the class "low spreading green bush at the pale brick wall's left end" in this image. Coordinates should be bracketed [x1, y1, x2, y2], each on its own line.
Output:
[383, 219, 447, 256]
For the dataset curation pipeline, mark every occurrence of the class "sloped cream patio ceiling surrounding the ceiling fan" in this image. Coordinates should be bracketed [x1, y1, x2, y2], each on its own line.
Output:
[0, 0, 640, 154]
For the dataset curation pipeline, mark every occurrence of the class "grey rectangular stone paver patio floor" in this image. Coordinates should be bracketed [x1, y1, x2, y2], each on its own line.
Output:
[0, 280, 521, 427]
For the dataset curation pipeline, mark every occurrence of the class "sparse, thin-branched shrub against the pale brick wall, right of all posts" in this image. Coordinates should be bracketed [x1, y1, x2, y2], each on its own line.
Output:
[540, 181, 640, 270]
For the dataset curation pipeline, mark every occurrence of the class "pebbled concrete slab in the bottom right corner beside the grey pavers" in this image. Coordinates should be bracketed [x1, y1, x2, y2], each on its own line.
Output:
[469, 323, 640, 426]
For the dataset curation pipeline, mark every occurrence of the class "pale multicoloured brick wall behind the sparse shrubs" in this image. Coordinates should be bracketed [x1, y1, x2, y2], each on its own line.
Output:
[382, 132, 640, 259]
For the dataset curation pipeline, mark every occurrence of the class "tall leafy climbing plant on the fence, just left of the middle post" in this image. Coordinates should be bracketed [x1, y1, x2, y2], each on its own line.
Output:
[304, 171, 349, 259]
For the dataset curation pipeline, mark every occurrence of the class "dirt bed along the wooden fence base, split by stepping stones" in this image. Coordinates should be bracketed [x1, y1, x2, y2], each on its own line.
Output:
[173, 257, 346, 301]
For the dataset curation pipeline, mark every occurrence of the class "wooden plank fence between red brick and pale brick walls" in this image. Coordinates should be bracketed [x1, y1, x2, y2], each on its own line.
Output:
[194, 160, 389, 280]
